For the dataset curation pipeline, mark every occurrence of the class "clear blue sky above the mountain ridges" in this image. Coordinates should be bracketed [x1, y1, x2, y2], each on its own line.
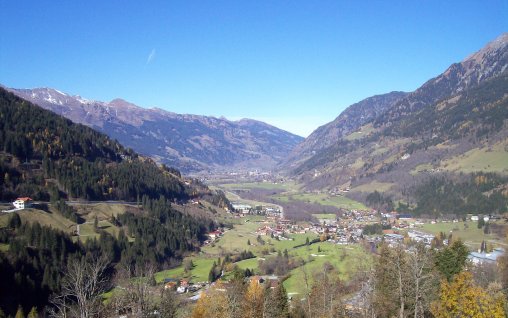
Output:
[0, 0, 508, 136]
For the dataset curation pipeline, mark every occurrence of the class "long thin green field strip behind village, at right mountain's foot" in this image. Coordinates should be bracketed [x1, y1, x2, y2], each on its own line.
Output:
[272, 193, 367, 210]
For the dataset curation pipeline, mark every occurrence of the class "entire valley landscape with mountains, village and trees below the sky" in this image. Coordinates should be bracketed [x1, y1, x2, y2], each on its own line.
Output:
[0, 18, 508, 318]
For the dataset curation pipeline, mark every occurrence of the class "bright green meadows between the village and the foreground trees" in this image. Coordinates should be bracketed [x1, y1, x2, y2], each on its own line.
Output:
[155, 209, 372, 294]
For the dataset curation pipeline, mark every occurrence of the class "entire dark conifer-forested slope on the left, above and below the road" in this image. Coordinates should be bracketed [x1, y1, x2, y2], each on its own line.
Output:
[0, 88, 230, 315]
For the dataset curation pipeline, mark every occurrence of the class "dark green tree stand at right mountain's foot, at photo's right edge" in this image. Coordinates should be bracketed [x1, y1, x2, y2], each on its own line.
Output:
[412, 173, 508, 217]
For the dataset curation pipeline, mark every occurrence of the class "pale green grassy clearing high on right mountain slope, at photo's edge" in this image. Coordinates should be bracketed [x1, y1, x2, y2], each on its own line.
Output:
[441, 142, 508, 173]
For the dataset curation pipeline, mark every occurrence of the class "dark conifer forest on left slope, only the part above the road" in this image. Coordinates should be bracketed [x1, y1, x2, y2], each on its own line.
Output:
[0, 88, 190, 201]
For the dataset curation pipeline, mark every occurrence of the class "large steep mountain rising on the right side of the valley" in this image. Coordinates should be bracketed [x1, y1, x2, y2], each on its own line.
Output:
[286, 33, 508, 198]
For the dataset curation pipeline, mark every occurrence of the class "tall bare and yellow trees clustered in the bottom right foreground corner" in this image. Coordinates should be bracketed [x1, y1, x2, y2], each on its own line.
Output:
[370, 241, 508, 318]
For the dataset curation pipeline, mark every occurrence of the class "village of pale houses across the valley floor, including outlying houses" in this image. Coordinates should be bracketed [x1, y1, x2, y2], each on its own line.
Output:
[3, 197, 505, 301]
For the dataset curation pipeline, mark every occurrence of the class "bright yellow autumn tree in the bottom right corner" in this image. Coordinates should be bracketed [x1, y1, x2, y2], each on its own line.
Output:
[431, 272, 505, 318]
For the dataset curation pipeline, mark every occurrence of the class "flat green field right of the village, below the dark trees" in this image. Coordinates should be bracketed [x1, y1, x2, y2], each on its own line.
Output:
[422, 221, 505, 250]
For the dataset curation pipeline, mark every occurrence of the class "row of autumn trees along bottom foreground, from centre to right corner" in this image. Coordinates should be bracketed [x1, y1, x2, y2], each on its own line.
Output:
[191, 241, 508, 318]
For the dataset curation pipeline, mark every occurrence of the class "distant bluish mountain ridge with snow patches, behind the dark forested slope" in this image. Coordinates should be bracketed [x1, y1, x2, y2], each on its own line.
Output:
[5, 88, 303, 172]
